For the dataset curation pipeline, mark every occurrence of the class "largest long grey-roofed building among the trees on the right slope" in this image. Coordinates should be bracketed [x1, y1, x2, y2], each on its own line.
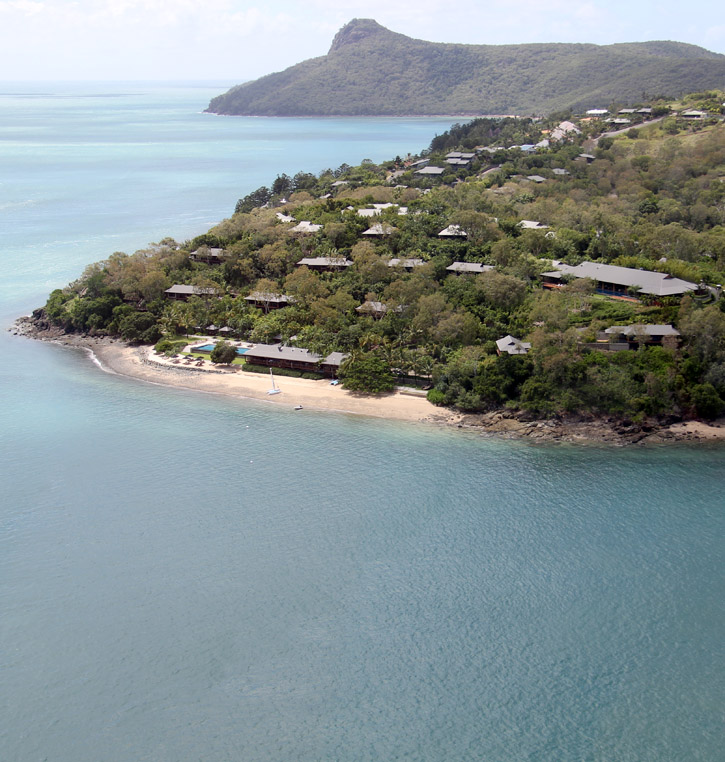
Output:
[542, 262, 697, 296]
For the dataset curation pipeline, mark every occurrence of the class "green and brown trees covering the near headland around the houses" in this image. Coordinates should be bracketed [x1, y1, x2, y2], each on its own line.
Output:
[37, 93, 725, 419]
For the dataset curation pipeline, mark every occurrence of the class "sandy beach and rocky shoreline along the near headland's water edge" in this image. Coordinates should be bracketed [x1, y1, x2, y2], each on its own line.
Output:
[9, 317, 725, 446]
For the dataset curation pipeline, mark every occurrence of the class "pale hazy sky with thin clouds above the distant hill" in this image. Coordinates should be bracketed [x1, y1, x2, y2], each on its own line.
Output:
[0, 0, 725, 81]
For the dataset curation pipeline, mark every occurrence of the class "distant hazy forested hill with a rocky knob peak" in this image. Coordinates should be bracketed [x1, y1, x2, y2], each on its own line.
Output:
[208, 19, 725, 116]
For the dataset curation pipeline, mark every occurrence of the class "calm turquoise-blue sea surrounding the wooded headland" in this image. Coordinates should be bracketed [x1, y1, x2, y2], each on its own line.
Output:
[0, 83, 725, 762]
